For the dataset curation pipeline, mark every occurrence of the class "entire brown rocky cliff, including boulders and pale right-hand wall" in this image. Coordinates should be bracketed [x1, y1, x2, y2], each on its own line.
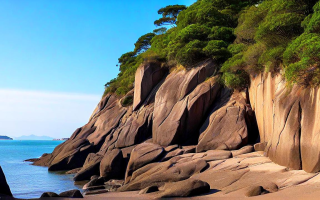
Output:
[34, 60, 320, 197]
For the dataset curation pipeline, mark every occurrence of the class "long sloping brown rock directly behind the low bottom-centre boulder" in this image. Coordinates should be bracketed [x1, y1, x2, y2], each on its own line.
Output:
[119, 156, 208, 191]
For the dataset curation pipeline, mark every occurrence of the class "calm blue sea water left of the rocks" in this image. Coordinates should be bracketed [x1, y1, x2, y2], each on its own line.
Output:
[0, 140, 80, 198]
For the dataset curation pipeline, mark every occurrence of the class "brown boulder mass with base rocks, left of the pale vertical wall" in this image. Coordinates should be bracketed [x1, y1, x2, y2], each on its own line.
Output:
[34, 60, 258, 197]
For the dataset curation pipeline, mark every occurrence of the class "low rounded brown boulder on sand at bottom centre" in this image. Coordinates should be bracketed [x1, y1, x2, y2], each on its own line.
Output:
[155, 178, 210, 198]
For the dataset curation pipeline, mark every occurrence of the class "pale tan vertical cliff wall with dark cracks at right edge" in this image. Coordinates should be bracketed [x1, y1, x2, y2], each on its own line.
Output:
[249, 73, 320, 172]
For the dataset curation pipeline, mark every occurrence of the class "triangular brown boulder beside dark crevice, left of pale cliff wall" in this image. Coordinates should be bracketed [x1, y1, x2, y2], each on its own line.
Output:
[196, 89, 248, 152]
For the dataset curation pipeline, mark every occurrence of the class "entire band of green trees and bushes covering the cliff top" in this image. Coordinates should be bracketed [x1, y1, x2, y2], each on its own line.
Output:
[106, 0, 320, 96]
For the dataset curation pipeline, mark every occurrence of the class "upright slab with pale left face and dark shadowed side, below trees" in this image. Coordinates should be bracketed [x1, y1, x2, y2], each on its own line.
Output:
[133, 62, 167, 110]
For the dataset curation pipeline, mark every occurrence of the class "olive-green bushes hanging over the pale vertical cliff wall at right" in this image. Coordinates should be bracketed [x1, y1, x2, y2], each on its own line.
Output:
[221, 0, 320, 87]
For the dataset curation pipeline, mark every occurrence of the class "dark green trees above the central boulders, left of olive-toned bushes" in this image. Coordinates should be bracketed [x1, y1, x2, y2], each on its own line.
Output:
[105, 0, 258, 96]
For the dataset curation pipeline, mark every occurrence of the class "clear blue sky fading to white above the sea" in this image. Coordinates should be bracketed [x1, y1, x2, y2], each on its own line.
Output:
[0, 0, 195, 138]
